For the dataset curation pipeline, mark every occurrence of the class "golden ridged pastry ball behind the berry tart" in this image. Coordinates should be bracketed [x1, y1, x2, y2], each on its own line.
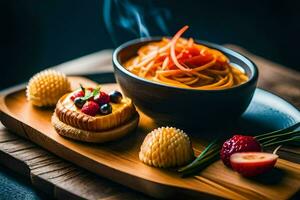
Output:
[26, 70, 71, 107]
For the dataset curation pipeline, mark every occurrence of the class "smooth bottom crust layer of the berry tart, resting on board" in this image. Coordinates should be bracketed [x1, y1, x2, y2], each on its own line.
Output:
[51, 113, 139, 143]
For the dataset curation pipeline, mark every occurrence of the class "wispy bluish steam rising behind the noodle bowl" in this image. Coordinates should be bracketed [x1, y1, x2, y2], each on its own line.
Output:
[103, 0, 170, 44]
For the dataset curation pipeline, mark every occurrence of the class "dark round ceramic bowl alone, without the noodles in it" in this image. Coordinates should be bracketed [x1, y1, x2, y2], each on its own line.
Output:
[113, 38, 258, 127]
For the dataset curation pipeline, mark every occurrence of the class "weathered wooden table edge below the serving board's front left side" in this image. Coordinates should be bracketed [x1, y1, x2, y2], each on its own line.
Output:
[0, 124, 149, 200]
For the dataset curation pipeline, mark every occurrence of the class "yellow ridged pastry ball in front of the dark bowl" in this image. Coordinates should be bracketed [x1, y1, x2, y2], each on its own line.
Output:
[139, 127, 194, 168]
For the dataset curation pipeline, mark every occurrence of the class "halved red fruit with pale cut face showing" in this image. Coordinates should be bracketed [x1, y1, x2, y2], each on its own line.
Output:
[230, 152, 278, 177]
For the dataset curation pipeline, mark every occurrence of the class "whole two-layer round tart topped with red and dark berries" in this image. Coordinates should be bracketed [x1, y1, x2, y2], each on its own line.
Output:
[51, 86, 139, 143]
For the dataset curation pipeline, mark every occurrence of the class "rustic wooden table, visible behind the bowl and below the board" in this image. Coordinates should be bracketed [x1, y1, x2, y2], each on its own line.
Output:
[0, 45, 300, 200]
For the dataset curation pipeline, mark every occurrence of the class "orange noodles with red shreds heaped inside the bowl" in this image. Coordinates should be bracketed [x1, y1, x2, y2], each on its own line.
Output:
[125, 26, 248, 90]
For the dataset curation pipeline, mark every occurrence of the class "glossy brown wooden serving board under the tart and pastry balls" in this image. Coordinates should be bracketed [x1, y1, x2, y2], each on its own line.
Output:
[0, 77, 300, 199]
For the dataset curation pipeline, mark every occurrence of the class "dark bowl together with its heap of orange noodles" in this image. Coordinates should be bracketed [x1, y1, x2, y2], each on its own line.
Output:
[113, 26, 258, 127]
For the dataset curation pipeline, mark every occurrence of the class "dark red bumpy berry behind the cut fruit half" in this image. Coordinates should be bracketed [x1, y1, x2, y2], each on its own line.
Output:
[220, 135, 262, 167]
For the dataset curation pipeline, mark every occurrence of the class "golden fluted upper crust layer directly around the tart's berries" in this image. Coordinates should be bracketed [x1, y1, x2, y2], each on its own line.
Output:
[55, 93, 137, 132]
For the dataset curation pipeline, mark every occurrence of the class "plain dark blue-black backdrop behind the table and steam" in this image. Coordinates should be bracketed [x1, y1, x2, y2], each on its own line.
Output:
[0, 0, 300, 89]
